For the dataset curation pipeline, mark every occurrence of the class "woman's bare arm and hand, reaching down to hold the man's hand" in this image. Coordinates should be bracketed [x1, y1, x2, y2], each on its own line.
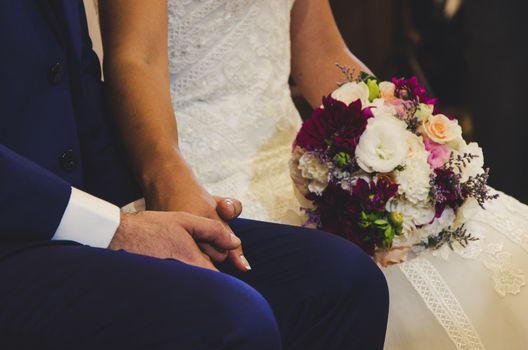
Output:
[99, 0, 247, 270]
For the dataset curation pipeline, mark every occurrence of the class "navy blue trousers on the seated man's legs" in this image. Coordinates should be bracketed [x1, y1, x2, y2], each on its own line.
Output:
[0, 219, 388, 350]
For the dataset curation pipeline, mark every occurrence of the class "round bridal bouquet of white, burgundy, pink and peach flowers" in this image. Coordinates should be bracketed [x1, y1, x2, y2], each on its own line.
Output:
[290, 68, 495, 265]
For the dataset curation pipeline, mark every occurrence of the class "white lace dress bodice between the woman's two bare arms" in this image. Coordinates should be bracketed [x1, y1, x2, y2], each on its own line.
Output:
[168, 0, 301, 221]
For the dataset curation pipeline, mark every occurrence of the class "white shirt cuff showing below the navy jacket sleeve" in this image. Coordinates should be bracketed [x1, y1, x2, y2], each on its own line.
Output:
[52, 187, 121, 248]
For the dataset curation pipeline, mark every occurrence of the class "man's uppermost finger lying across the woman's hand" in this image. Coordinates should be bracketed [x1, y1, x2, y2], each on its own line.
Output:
[178, 213, 242, 250]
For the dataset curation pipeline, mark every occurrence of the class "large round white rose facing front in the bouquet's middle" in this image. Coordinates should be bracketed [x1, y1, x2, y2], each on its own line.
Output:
[356, 117, 409, 173]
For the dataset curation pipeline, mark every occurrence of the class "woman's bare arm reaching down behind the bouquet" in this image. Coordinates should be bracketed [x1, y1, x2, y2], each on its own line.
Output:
[291, 0, 371, 107]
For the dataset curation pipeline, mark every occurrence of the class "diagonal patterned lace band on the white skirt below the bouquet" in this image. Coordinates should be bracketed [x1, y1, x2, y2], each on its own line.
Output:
[399, 257, 484, 350]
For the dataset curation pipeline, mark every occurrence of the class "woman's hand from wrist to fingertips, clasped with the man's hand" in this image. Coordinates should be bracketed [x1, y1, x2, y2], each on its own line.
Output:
[145, 165, 251, 271]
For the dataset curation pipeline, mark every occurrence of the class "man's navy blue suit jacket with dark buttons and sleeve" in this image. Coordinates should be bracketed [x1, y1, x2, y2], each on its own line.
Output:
[0, 0, 140, 255]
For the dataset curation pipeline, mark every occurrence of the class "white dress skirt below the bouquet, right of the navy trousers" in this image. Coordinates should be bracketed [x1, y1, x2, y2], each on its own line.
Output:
[384, 195, 528, 350]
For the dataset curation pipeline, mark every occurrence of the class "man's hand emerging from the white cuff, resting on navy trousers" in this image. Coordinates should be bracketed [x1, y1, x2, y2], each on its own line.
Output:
[109, 211, 241, 271]
